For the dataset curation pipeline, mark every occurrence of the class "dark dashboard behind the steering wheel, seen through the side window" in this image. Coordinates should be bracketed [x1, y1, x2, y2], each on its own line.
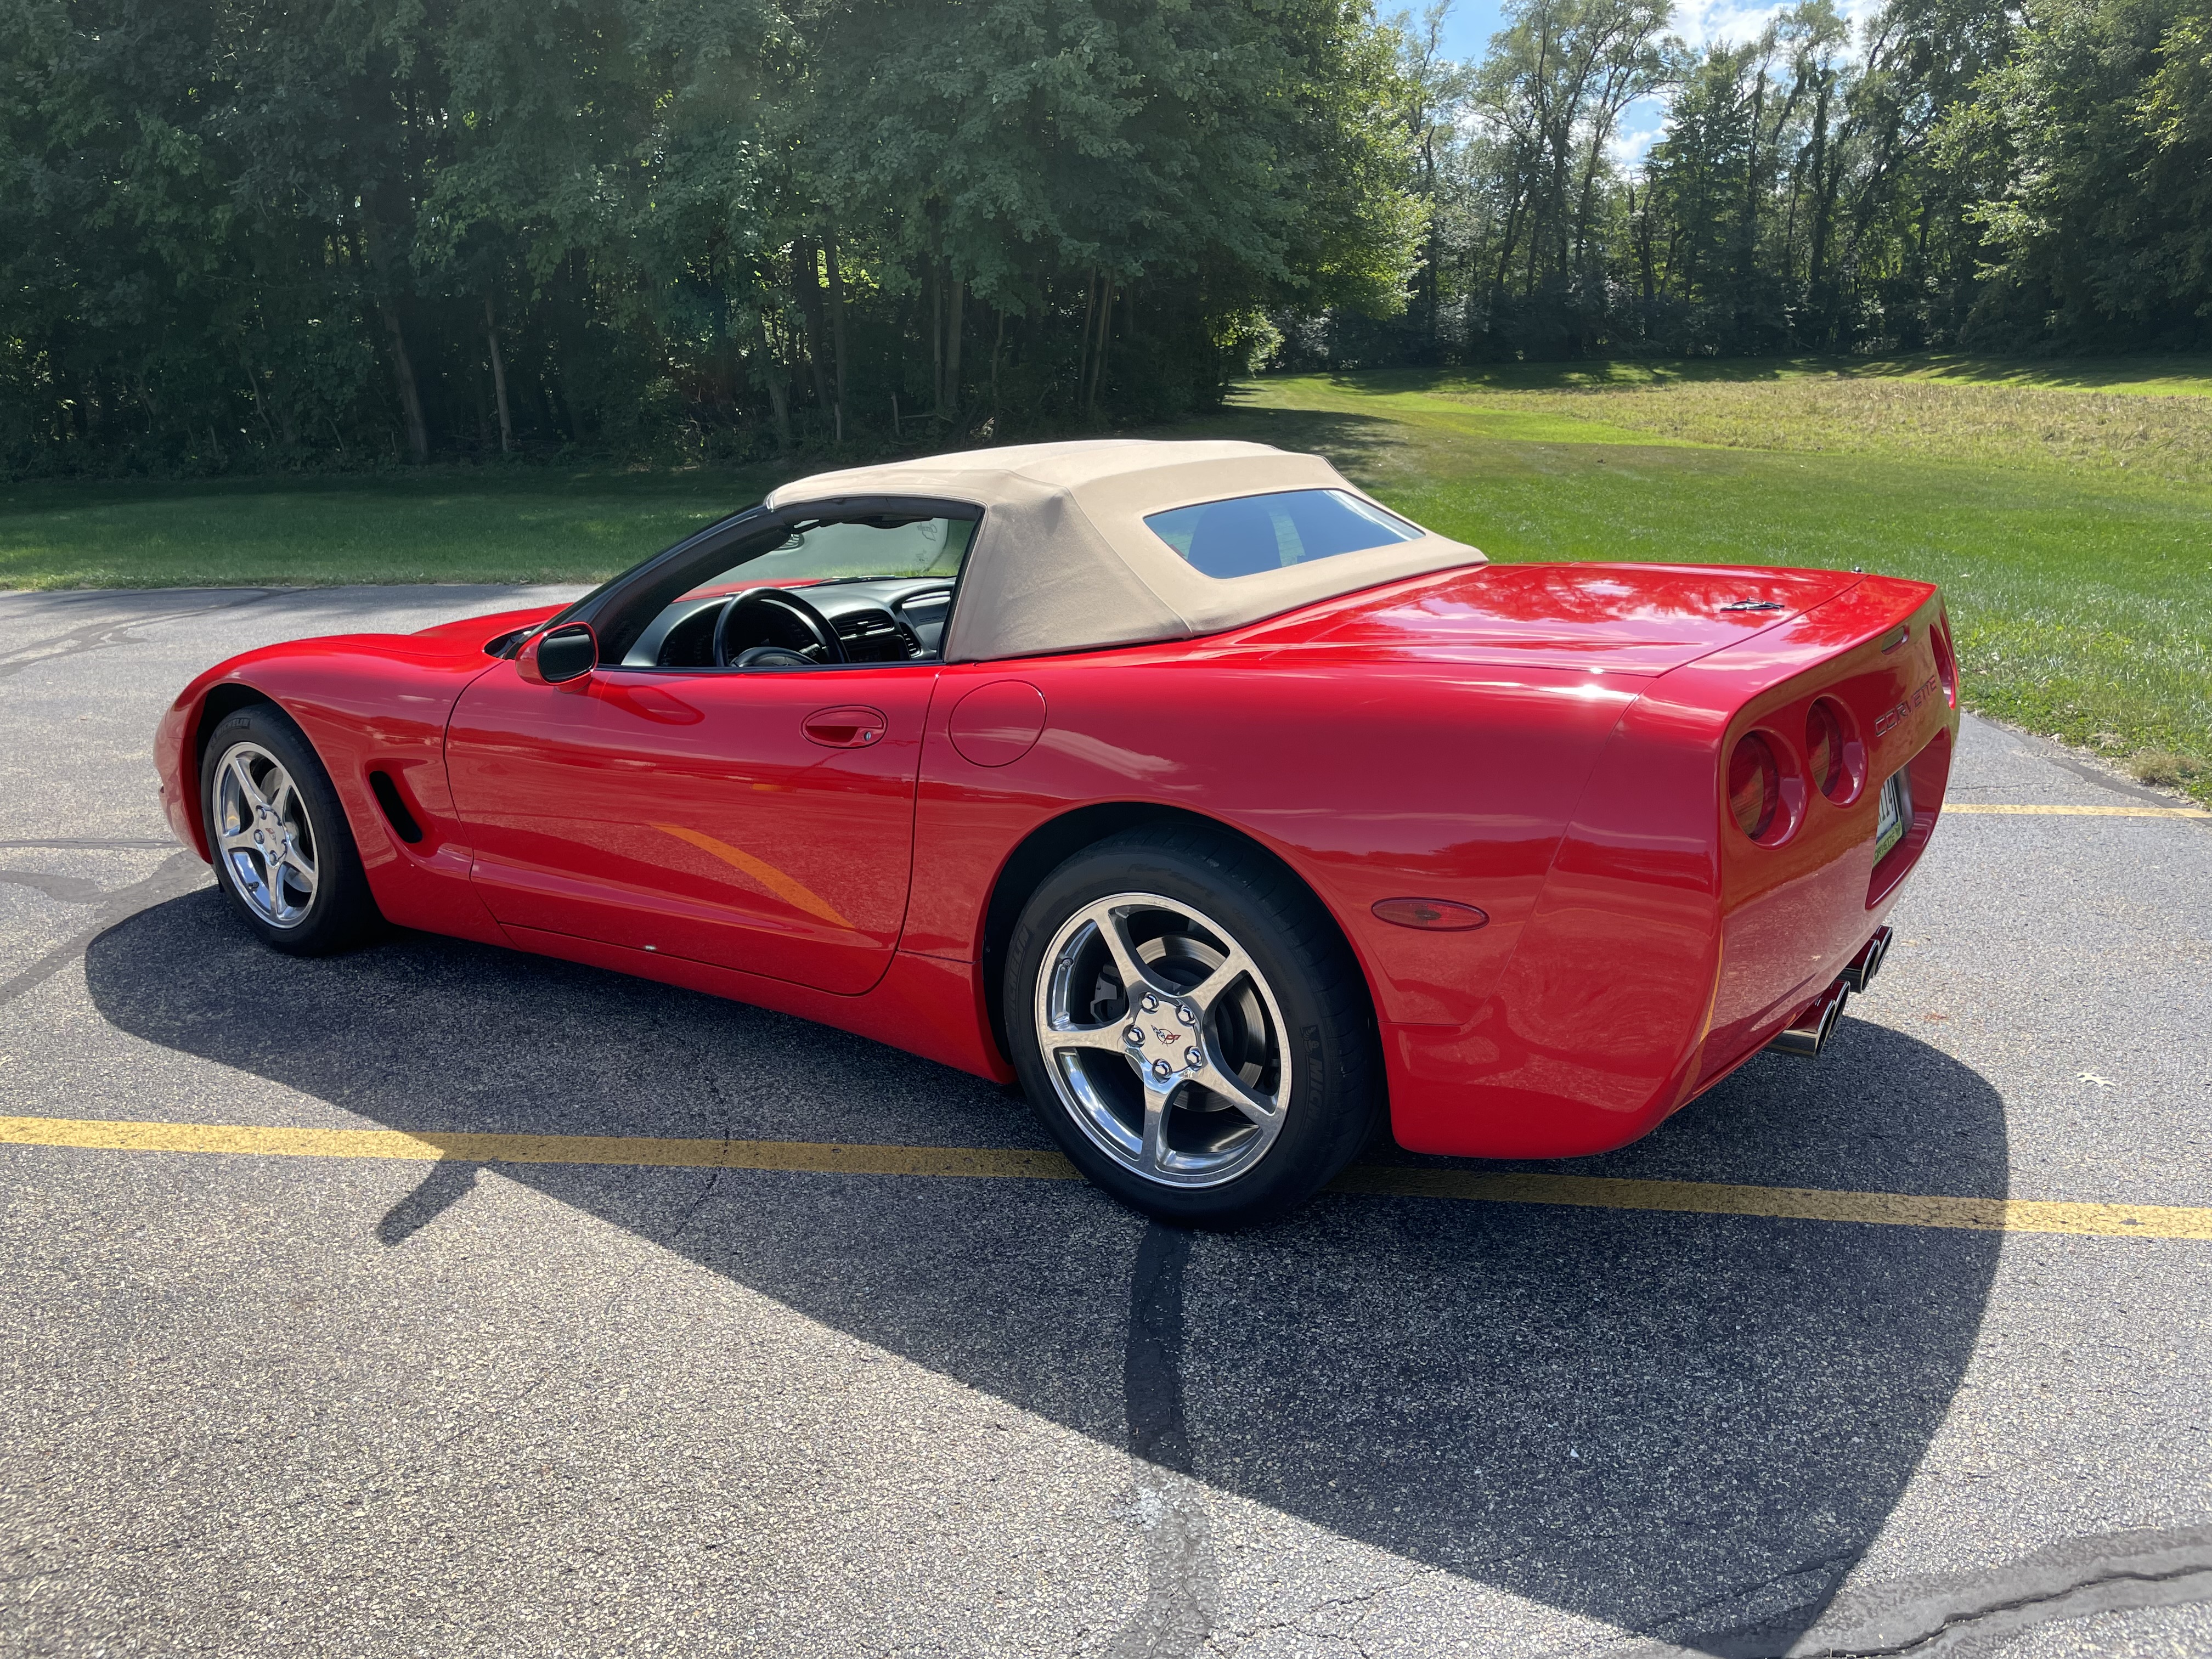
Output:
[622, 575, 953, 668]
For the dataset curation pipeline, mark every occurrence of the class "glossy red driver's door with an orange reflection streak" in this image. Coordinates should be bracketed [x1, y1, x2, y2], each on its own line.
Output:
[447, 664, 938, 995]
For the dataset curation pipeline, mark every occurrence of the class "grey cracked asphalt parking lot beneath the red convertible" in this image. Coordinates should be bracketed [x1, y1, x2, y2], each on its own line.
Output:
[0, 589, 2212, 1659]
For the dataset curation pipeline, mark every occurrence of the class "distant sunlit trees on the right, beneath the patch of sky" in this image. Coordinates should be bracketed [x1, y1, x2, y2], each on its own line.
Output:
[1274, 0, 2212, 367]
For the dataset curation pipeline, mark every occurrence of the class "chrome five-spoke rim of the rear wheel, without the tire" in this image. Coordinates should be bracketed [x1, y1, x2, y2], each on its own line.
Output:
[1035, 894, 1292, 1188]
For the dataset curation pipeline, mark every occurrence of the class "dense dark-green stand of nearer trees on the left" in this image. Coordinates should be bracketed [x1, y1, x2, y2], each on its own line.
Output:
[0, 0, 1425, 473]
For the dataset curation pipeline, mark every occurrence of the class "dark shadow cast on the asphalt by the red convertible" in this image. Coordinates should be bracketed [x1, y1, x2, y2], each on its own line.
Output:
[86, 889, 2006, 1652]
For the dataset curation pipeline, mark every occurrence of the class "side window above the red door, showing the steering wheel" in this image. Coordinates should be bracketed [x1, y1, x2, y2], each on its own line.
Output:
[622, 511, 978, 670]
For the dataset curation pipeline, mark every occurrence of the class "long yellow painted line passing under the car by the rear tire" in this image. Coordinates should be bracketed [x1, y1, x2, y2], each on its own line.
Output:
[0, 1117, 2212, 1239]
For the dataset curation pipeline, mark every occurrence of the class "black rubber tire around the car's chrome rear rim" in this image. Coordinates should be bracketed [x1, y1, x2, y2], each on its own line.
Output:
[1005, 825, 1385, 1228]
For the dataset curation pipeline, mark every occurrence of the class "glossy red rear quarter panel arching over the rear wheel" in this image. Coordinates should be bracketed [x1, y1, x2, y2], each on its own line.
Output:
[900, 646, 1644, 1092]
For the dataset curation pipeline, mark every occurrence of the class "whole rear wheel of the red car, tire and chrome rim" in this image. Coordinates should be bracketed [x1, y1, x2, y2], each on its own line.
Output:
[1007, 830, 1383, 1228]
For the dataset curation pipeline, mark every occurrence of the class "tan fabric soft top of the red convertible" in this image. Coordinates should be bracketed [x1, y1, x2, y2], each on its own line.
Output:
[768, 438, 1484, 662]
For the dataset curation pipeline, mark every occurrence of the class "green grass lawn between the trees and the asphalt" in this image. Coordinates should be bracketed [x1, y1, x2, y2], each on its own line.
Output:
[0, 358, 2212, 799]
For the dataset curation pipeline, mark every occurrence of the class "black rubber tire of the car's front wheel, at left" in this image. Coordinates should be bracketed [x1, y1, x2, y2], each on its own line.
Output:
[199, 703, 383, 956]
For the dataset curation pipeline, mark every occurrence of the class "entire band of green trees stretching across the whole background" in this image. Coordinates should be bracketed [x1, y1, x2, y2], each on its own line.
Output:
[0, 0, 2212, 462]
